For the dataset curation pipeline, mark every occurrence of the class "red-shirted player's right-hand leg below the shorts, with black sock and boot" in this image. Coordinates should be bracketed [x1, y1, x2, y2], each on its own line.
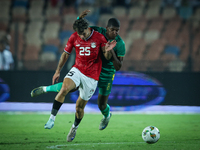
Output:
[67, 96, 88, 142]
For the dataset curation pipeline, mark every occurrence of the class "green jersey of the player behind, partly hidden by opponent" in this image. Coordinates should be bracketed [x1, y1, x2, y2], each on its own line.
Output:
[91, 26, 125, 80]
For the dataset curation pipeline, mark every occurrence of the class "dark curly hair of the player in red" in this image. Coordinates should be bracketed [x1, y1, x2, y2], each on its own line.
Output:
[73, 18, 89, 35]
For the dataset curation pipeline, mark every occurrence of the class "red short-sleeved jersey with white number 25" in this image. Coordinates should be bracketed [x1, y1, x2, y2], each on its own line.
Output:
[64, 30, 107, 80]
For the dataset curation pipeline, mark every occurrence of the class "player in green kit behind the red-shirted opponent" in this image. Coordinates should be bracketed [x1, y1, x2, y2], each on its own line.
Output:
[31, 10, 125, 130]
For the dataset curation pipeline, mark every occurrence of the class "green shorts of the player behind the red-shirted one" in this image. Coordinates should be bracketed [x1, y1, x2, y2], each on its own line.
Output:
[98, 74, 115, 96]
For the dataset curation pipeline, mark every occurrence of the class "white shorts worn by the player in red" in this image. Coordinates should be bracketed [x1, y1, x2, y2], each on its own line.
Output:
[65, 67, 98, 101]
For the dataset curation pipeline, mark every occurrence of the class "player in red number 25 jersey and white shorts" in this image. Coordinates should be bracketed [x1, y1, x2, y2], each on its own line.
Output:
[44, 19, 116, 142]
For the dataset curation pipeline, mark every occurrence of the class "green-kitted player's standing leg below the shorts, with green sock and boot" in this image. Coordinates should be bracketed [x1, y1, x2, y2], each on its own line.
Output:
[98, 94, 112, 130]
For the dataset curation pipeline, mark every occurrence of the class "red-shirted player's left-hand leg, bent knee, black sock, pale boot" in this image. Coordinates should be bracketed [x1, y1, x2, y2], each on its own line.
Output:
[44, 78, 76, 129]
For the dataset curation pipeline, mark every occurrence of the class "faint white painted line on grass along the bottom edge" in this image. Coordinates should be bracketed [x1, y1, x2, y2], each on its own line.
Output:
[46, 142, 145, 149]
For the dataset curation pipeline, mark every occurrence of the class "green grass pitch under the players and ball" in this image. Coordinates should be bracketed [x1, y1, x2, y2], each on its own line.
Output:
[0, 112, 200, 150]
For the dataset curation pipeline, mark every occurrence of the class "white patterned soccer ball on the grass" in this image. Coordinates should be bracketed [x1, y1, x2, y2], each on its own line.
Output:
[142, 126, 160, 144]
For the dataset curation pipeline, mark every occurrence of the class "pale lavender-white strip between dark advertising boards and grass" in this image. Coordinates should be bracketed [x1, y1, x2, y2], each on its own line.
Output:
[0, 102, 200, 114]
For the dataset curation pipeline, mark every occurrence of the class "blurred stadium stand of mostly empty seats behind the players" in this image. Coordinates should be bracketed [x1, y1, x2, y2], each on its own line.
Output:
[0, 0, 200, 71]
